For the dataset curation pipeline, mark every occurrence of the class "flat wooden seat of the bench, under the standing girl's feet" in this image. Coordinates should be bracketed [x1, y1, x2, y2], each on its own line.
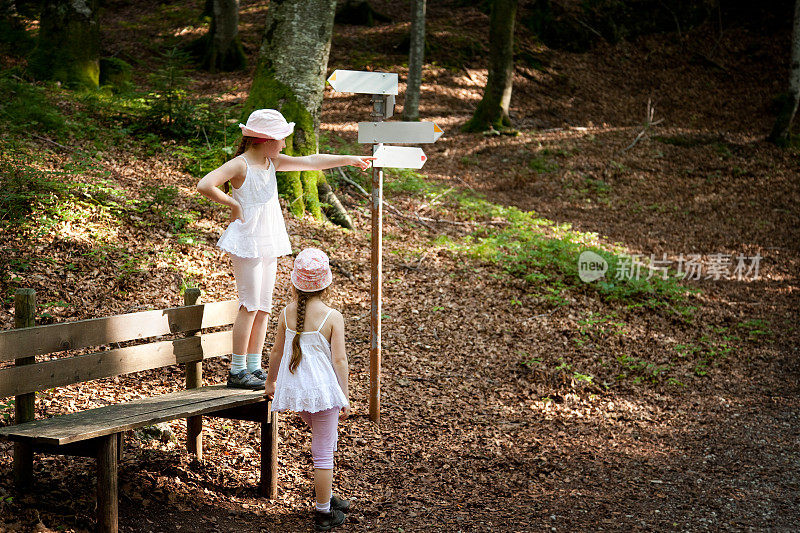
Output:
[0, 385, 266, 445]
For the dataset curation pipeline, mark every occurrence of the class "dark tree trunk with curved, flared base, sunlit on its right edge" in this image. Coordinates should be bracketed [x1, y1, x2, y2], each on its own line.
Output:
[464, 0, 517, 131]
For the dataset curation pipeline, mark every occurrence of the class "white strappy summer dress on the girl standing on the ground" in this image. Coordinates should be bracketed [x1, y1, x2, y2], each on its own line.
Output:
[272, 308, 349, 413]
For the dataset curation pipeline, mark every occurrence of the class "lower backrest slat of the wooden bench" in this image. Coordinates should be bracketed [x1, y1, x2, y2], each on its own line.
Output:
[0, 331, 232, 398]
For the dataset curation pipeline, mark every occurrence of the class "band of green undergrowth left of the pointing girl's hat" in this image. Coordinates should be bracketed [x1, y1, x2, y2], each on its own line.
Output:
[0, 50, 240, 163]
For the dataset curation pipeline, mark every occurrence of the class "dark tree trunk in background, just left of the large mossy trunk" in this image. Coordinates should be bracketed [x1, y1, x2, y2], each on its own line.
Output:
[190, 0, 247, 73]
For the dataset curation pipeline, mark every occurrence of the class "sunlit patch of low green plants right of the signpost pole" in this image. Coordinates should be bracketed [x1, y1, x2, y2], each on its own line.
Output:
[384, 169, 695, 312]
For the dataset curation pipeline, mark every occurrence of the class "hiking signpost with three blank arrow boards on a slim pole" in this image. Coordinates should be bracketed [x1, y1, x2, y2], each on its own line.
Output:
[328, 70, 443, 422]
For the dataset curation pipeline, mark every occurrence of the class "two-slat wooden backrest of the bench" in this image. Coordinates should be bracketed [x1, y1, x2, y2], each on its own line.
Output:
[0, 300, 239, 398]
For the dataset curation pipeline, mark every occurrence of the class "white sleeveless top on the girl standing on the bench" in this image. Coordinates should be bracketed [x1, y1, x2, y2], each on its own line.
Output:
[217, 155, 292, 257]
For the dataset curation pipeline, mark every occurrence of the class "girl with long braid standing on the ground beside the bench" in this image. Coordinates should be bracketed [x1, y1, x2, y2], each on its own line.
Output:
[265, 248, 350, 531]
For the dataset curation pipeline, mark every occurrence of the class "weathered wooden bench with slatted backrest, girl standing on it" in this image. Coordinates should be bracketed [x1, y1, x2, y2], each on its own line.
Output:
[0, 289, 278, 532]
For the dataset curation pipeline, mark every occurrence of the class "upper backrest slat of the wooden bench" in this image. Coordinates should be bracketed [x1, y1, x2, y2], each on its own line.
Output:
[0, 300, 239, 361]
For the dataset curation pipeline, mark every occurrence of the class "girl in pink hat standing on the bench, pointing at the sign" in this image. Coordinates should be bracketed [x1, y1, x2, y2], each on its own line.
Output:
[197, 109, 374, 390]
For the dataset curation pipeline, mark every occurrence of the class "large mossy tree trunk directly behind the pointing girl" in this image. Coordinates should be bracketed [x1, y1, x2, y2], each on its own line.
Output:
[243, 0, 352, 227]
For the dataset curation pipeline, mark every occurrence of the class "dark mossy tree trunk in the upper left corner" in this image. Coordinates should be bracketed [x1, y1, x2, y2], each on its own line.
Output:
[28, 0, 100, 89]
